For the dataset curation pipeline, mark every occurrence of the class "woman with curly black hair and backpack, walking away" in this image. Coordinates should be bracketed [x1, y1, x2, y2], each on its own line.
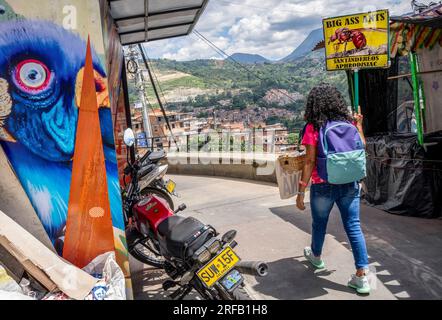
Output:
[296, 84, 370, 294]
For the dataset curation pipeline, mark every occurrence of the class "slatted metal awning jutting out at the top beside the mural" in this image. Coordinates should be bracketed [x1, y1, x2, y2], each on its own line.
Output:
[109, 0, 209, 45]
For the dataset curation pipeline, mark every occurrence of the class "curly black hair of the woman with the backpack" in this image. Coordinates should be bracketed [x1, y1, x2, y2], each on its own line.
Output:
[305, 83, 352, 130]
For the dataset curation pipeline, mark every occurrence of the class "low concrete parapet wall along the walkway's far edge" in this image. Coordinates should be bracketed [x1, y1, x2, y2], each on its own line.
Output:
[167, 152, 276, 183]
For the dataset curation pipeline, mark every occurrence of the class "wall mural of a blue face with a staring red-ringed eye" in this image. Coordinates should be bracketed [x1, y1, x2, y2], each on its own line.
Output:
[0, 0, 130, 296]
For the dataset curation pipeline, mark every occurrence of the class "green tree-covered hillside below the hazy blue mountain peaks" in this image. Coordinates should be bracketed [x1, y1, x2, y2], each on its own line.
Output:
[131, 50, 349, 120]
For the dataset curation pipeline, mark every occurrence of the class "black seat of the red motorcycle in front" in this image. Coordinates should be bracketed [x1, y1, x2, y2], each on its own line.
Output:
[158, 215, 212, 259]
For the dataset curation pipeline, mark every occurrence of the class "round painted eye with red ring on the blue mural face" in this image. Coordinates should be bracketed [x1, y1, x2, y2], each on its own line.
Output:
[15, 59, 51, 93]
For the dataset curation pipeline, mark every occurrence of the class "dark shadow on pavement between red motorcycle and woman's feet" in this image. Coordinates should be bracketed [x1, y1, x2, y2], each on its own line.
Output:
[253, 256, 354, 300]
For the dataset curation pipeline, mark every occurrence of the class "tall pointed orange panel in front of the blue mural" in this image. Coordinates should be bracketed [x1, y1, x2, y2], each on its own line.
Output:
[63, 39, 114, 268]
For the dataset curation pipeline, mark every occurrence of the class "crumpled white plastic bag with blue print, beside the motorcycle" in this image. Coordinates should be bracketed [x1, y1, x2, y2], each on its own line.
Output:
[83, 252, 126, 300]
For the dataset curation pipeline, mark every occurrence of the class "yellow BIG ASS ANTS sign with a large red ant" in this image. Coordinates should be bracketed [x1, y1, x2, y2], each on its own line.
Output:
[322, 10, 390, 71]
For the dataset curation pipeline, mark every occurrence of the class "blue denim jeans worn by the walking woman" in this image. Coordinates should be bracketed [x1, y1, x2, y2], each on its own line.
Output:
[310, 182, 368, 269]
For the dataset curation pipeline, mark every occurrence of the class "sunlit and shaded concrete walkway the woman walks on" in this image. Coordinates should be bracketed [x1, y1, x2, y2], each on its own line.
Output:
[131, 175, 442, 299]
